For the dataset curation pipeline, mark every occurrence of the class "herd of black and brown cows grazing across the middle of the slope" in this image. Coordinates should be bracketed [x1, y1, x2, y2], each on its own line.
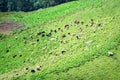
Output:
[3, 19, 102, 75]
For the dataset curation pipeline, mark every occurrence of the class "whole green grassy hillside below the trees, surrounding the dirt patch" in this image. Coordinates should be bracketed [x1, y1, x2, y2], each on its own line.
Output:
[0, 0, 120, 80]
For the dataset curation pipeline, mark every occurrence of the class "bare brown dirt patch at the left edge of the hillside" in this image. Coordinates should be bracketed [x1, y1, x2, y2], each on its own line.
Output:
[0, 21, 22, 34]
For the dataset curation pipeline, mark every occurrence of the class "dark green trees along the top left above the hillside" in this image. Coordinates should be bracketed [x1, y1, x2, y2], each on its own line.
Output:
[0, 0, 72, 12]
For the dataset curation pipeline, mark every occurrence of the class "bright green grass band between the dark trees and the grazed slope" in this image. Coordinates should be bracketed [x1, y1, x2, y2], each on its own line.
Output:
[0, 0, 99, 27]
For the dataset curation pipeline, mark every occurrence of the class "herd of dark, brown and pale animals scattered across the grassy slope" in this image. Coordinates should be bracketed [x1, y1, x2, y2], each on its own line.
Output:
[3, 19, 106, 76]
